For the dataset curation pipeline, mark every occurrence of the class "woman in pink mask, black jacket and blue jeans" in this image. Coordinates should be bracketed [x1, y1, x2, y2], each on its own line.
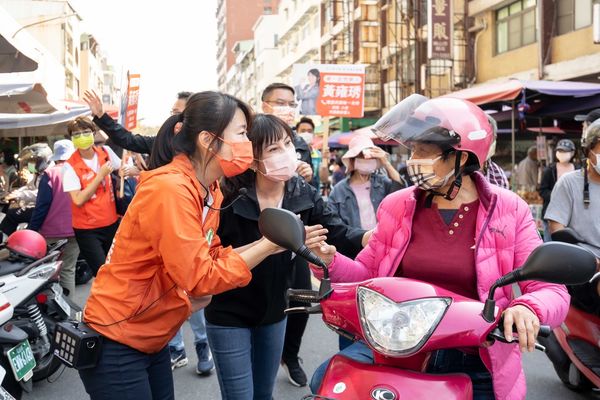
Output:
[205, 114, 365, 400]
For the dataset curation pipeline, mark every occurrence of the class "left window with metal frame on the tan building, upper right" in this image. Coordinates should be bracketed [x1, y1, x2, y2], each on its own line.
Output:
[496, 0, 536, 54]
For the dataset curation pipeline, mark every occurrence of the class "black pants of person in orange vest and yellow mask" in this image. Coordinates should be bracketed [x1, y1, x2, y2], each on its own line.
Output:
[73, 221, 119, 276]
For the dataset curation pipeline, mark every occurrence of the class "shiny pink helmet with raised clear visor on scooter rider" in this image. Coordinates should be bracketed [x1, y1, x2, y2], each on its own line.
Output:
[373, 94, 494, 166]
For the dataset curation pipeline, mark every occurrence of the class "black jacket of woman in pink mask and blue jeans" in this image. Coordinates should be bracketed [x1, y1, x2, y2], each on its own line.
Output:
[205, 177, 365, 327]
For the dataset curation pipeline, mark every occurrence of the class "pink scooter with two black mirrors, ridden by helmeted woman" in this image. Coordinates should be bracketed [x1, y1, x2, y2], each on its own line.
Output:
[259, 209, 596, 400]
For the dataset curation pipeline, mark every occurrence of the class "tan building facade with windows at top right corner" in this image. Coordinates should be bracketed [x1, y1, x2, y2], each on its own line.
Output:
[468, 0, 600, 83]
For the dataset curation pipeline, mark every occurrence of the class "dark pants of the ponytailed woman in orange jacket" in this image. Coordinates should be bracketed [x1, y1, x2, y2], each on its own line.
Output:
[79, 338, 175, 400]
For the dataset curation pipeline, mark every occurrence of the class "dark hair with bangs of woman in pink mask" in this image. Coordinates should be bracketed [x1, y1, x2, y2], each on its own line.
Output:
[222, 114, 293, 203]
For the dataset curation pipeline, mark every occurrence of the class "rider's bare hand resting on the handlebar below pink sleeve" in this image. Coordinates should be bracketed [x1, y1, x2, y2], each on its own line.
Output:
[503, 305, 540, 353]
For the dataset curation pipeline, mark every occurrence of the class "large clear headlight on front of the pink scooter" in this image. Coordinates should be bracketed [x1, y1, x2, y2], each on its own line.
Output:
[357, 287, 451, 356]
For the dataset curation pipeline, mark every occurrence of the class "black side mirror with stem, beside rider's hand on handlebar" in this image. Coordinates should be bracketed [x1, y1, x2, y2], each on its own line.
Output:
[483, 242, 596, 322]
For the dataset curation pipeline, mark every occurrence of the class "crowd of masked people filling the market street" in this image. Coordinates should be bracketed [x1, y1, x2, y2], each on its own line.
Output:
[0, 85, 600, 400]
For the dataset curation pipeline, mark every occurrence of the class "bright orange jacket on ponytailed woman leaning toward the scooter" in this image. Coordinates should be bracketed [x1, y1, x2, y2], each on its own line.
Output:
[84, 155, 252, 353]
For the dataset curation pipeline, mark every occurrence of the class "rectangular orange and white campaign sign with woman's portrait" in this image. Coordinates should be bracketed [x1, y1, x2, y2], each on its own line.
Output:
[292, 64, 365, 118]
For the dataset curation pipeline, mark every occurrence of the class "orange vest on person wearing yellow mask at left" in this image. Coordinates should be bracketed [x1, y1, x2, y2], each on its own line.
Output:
[67, 146, 118, 229]
